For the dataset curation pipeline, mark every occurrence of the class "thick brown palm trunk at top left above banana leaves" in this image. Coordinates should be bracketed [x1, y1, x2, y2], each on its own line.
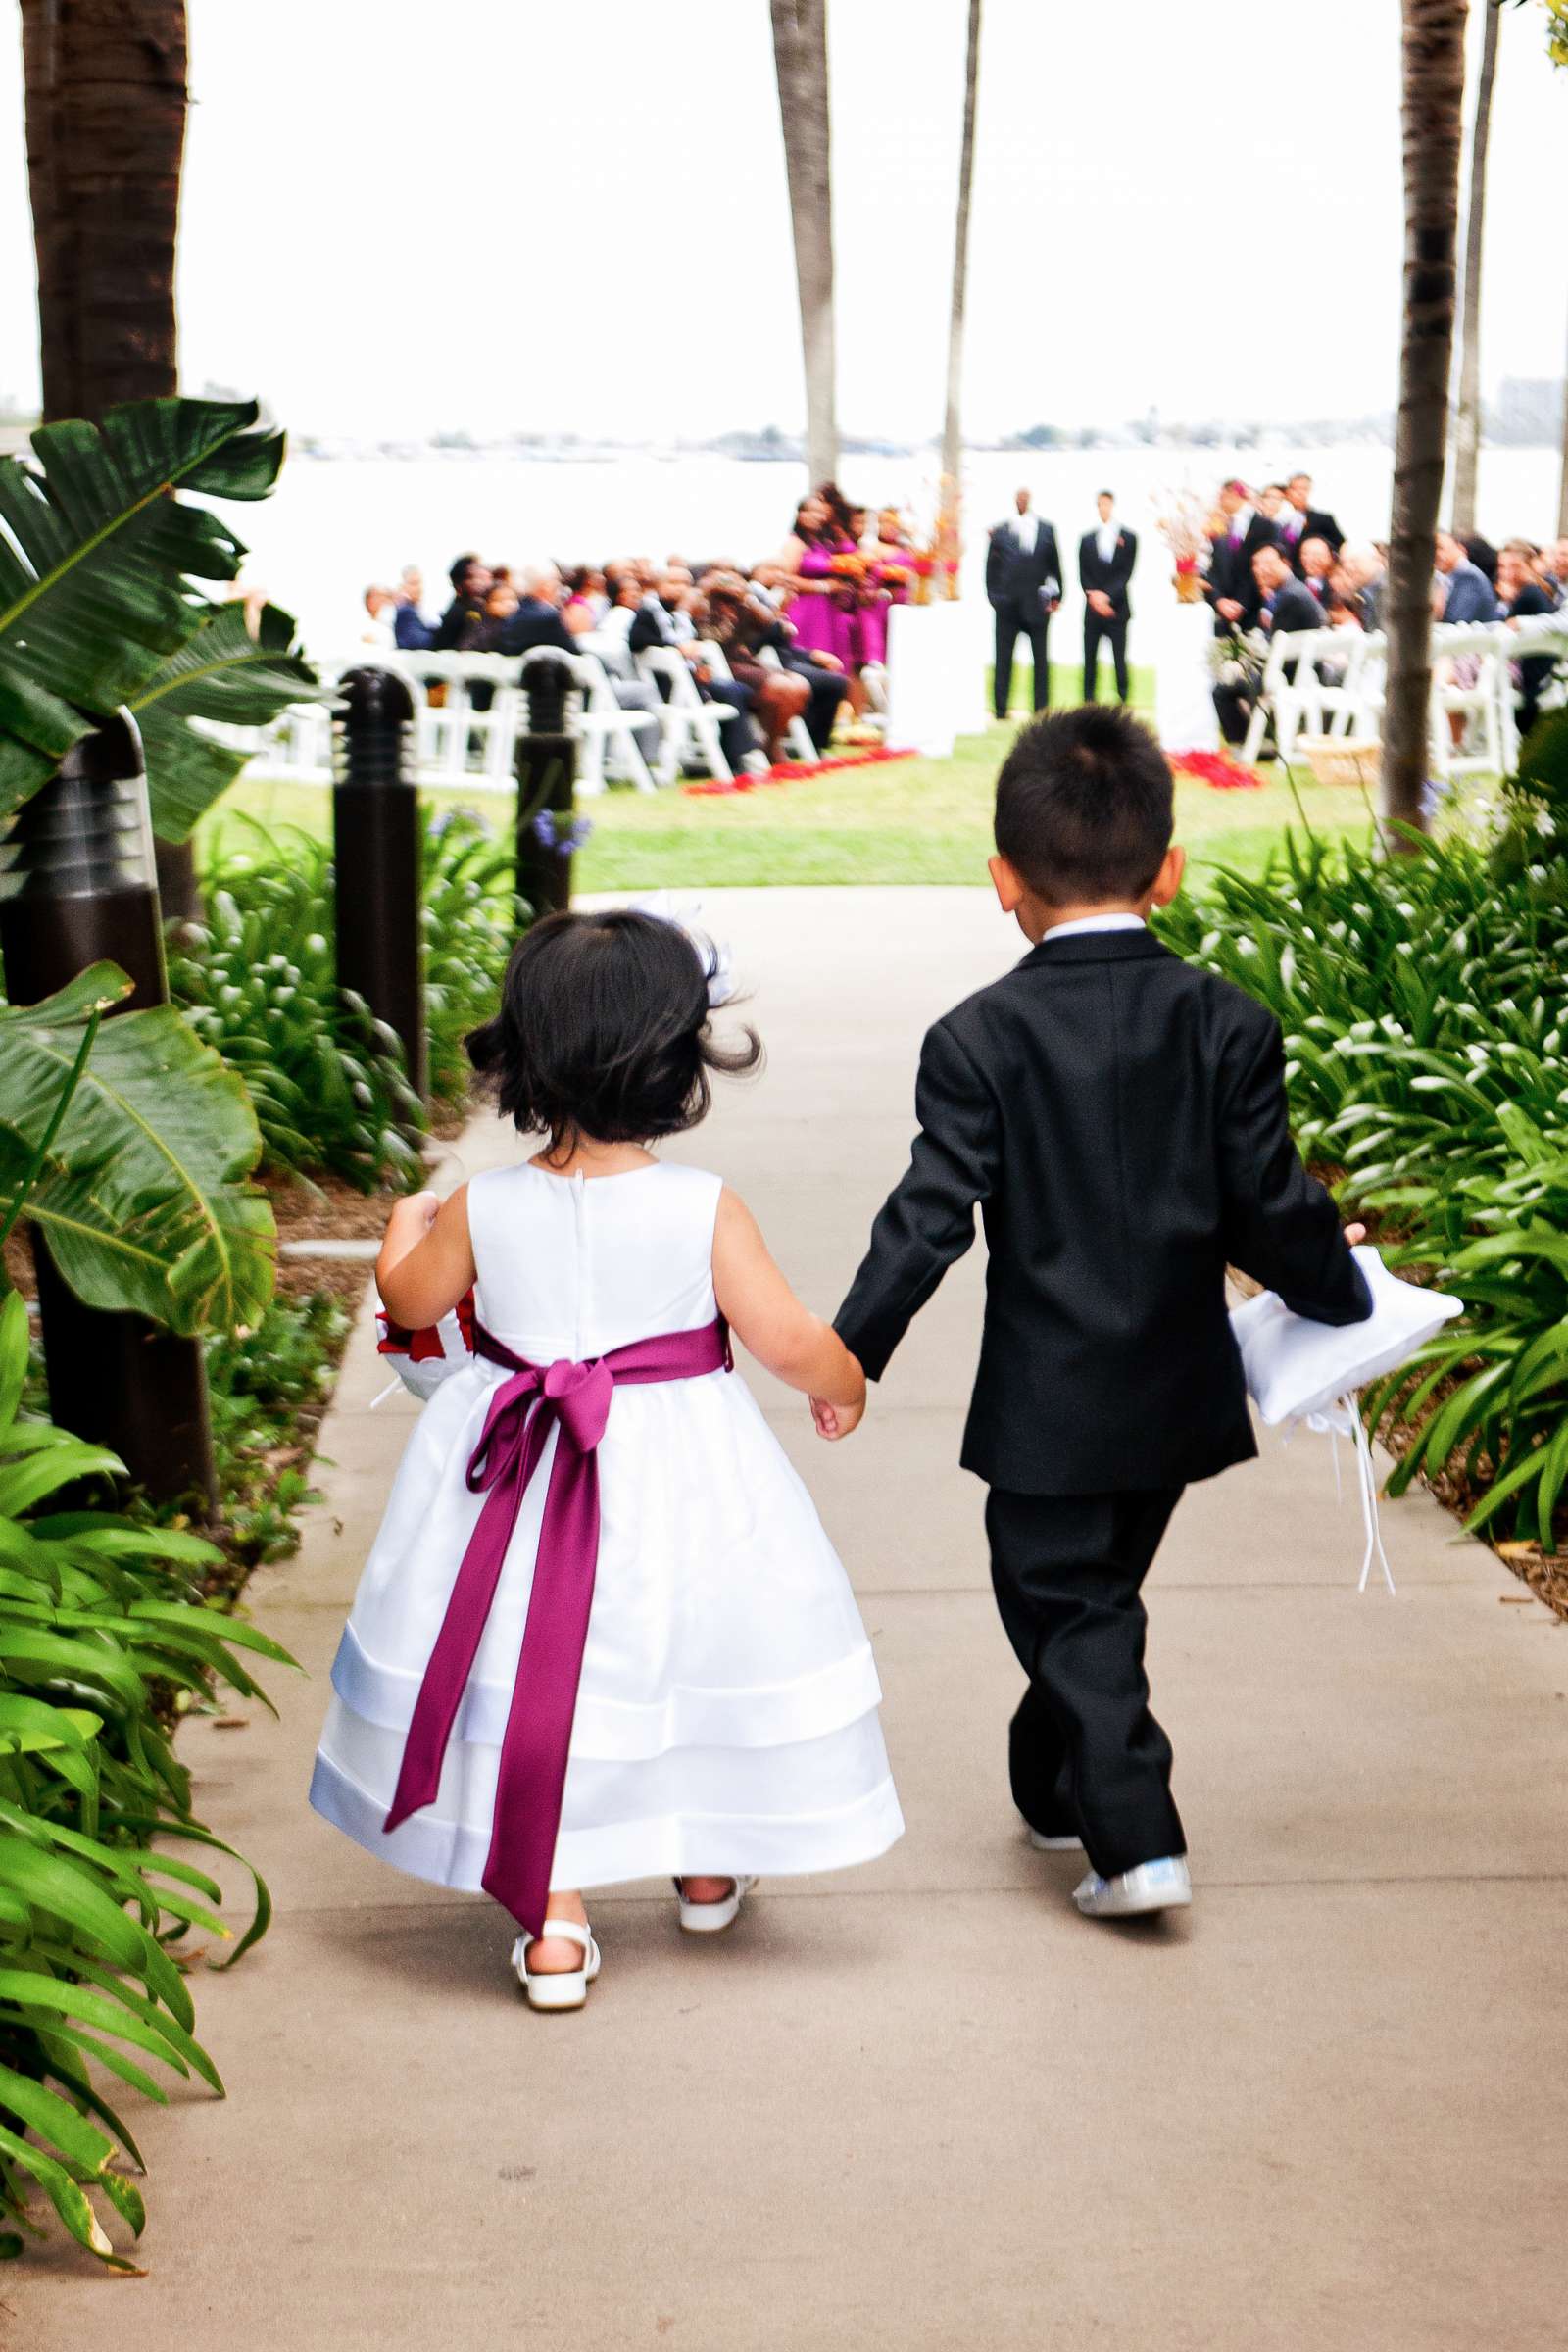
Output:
[22, 0, 186, 418]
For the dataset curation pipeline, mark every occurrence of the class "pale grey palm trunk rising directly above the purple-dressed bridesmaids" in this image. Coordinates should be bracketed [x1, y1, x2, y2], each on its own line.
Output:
[771, 0, 839, 482]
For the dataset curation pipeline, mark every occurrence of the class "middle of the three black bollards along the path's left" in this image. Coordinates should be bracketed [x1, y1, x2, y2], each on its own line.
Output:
[331, 668, 428, 1096]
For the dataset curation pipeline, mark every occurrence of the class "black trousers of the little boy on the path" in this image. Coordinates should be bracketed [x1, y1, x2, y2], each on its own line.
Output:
[985, 1487, 1187, 1880]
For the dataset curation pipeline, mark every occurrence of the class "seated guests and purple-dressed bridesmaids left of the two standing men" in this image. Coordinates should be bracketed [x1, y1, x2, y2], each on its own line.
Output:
[362, 482, 941, 774]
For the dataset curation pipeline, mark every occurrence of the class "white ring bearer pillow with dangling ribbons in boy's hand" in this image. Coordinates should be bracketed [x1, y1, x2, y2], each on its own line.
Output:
[1230, 1242, 1464, 1592]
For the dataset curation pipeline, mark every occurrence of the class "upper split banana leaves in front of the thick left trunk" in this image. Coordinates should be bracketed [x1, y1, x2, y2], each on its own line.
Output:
[0, 400, 313, 842]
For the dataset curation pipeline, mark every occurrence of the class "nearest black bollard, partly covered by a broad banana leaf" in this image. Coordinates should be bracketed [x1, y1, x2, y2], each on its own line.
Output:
[0, 710, 219, 1505]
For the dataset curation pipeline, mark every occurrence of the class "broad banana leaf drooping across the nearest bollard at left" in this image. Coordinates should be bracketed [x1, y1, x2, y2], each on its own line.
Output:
[0, 964, 275, 1334]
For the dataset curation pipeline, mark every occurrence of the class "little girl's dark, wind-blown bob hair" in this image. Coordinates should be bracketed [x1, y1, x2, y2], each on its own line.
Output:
[464, 910, 761, 1148]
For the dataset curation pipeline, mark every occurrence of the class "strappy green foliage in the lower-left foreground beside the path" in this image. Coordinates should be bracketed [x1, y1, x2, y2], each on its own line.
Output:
[0, 1279, 291, 2270]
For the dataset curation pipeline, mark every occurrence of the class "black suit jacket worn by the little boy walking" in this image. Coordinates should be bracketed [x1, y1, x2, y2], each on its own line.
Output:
[837, 931, 1371, 1494]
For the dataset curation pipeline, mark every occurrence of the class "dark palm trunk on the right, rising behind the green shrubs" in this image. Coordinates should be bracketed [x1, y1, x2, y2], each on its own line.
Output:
[1382, 0, 1467, 847]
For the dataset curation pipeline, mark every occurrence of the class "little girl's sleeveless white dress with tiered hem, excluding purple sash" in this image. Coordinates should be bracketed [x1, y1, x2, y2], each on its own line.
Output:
[311, 1164, 903, 1888]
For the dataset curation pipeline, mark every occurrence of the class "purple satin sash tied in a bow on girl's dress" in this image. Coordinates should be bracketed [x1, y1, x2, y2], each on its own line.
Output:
[383, 1319, 733, 1936]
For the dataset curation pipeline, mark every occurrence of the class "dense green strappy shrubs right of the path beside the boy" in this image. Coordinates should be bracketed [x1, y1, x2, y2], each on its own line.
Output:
[1163, 811, 1568, 1550]
